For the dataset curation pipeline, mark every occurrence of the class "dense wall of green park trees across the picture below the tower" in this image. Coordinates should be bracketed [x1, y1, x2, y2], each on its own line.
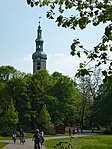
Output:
[0, 64, 112, 134]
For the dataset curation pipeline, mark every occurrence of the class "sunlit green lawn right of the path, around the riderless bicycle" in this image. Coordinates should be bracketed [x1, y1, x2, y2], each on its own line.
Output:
[45, 135, 112, 149]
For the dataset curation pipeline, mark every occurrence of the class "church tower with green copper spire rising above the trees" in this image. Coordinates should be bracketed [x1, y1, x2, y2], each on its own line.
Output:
[32, 21, 47, 73]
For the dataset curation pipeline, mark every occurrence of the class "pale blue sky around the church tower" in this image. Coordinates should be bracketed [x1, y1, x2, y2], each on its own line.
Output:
[0, 0, 107, 77]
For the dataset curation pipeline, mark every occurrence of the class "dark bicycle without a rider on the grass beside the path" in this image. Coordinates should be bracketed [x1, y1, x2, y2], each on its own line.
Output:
[54, 142, 73, 149]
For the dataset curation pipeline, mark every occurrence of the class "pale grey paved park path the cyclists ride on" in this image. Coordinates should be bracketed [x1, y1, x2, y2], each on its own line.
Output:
[0, 133, 95, 149]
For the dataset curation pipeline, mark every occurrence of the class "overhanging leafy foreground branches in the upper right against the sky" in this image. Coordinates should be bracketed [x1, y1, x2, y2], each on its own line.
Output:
[27, 0, 112, 81]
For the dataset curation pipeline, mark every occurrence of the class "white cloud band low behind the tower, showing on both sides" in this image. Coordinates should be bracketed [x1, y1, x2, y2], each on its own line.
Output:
[12, 53, 79, 77]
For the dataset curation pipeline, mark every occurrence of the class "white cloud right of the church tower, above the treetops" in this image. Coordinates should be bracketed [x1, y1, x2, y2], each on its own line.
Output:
[47, 53, 79, 77]
